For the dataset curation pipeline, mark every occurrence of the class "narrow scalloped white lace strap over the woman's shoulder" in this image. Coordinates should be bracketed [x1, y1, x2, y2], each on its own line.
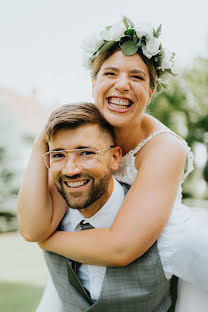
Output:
[131, 129, 194, 180]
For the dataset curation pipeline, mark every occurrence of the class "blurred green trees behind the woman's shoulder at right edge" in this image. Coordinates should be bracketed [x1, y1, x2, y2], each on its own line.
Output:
[148, 58, 208, 196]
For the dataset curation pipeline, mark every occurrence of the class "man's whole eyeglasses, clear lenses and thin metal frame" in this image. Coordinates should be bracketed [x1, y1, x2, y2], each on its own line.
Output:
[42, 146, 114, 171]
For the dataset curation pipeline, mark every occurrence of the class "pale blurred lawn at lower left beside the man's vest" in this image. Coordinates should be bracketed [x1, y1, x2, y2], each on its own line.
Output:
[0, 233, 48, 312]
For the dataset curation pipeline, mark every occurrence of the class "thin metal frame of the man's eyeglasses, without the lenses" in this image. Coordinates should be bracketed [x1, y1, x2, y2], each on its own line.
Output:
[42, 145, 115, 171]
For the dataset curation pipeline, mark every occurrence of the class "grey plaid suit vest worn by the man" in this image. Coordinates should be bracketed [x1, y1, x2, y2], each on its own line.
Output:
[44, 185, 176, 312]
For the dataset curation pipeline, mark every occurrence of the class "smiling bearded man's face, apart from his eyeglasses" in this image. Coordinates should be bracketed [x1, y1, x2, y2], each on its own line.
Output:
[49, 124, 120, 216]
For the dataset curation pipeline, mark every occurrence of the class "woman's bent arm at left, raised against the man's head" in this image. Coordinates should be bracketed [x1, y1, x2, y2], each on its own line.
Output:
[18, 131, 66, 241]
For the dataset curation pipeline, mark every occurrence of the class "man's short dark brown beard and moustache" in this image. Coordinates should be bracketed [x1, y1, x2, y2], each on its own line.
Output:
[54, 171, 110, 209]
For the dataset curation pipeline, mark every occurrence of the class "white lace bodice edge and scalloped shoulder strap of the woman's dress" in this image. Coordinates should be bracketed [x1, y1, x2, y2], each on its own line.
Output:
[114, 129, 194, 185]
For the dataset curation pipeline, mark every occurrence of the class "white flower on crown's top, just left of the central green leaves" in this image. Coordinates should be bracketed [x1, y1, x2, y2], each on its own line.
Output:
[100, 21, 126, 41]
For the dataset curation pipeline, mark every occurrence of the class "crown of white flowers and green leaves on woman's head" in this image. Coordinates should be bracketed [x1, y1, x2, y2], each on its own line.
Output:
[81, 16, 176, 92]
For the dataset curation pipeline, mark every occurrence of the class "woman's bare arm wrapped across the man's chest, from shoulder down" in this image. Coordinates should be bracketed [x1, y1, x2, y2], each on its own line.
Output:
[39, 134, 186, 266]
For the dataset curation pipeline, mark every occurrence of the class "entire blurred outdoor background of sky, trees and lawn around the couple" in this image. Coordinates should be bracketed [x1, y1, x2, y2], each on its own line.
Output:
[0, 0, 208, 312]
